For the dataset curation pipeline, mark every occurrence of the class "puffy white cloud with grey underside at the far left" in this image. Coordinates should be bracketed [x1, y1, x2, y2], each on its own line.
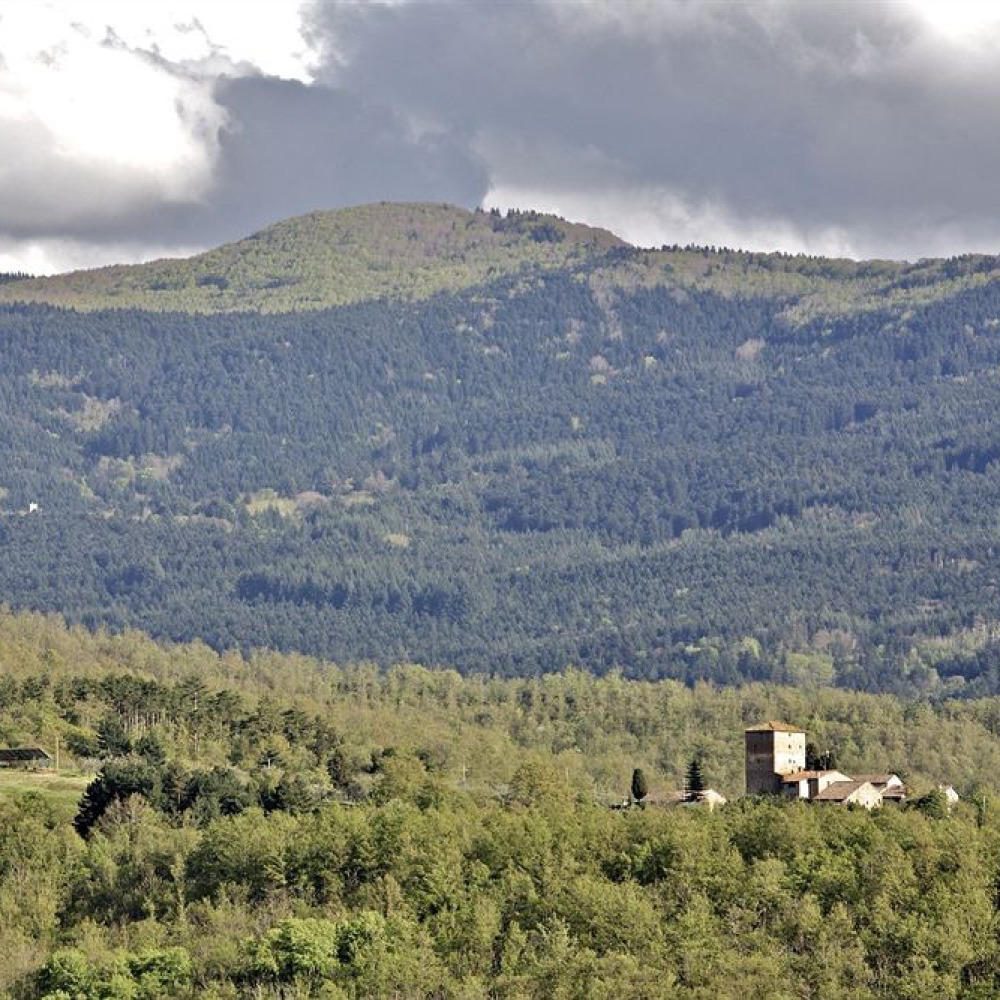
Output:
[0, 5, 223, 236]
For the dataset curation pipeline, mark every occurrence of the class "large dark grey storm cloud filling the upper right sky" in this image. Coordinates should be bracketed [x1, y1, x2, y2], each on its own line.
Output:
[306, 0, 1000, 258]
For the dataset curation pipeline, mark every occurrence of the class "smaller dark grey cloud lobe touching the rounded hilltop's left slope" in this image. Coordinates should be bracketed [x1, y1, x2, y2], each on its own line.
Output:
[152, 77, 488, 244]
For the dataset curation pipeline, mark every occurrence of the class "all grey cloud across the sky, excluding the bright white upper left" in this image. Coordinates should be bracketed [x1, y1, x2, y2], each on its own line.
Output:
[0, 0, 1000, 266]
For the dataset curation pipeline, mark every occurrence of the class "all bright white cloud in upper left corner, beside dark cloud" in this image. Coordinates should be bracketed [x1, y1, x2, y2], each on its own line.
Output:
[0, 0, 314, 261]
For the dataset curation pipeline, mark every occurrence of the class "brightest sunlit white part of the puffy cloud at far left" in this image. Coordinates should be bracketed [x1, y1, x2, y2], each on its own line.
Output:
[0, 7, 223, 197]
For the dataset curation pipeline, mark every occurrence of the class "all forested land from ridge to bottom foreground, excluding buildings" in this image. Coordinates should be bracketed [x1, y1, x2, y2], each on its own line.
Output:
[0, 205, 1000, 1000]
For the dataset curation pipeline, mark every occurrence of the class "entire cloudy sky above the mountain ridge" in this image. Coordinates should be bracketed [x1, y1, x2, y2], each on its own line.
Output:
[0, 0, 1000, 274]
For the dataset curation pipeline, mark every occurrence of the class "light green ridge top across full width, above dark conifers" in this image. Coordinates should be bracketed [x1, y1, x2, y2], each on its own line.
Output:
[0, 202, 1000, 326]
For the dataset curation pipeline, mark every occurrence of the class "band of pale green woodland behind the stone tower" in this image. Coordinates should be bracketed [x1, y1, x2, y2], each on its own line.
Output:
[0, 614, 1000, 802]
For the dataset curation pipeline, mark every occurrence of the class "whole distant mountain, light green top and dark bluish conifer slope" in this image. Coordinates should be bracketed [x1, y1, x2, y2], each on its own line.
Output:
[0, 205, 1000, 696]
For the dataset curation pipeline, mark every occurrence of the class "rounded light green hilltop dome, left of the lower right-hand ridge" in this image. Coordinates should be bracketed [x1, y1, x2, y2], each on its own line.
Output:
[0, 204, 622, 312]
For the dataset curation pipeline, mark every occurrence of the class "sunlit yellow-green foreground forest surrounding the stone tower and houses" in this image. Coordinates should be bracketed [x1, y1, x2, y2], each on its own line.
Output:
[0, 613, 1000, 1000]
